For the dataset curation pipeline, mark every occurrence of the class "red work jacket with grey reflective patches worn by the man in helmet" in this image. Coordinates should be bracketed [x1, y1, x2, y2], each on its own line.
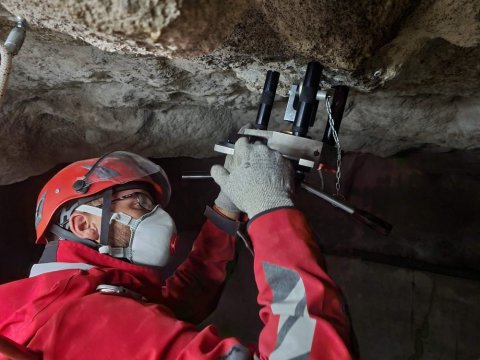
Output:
[0, 208, 351, 360]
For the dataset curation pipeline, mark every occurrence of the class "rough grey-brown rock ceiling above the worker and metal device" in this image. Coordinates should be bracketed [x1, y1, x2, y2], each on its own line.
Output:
[0, 0, 480, 184]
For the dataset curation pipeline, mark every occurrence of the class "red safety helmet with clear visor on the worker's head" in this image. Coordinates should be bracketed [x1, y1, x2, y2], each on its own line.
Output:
[35, 151, 171, 244]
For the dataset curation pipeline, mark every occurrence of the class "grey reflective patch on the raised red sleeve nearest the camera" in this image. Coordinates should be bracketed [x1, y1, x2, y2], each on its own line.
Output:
[263, 262, 316, 360]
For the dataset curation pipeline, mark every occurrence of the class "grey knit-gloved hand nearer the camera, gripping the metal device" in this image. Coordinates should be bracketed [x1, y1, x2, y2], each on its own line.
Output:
[210, 138, 294, 218]
